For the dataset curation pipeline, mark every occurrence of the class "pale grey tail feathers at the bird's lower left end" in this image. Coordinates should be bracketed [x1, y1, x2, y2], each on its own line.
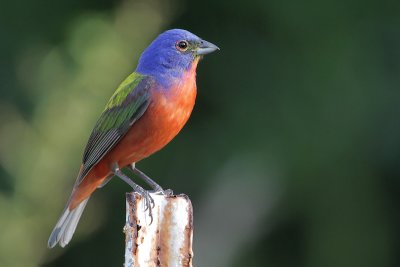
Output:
[47, 198, 89, 248]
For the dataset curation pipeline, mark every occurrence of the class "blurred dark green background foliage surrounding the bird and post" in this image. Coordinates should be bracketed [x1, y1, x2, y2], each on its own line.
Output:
[0, 0, 400, 267]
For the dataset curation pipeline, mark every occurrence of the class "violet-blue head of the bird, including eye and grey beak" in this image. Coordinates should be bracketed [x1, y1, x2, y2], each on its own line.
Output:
[136, 29, 218, 84]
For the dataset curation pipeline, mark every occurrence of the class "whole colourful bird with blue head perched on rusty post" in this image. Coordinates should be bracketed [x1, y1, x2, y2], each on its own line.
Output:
[47, 29, 219, 248]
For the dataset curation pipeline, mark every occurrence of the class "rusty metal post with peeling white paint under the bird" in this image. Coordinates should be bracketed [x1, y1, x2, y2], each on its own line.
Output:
[124, 193, 193, 267]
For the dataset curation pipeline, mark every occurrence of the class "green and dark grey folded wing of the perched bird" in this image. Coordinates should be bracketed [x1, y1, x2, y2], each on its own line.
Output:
[77, 72, 154, 183]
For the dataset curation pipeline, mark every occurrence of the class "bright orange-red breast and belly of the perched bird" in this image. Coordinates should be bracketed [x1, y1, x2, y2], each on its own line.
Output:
[104, 84, 196, 168]
